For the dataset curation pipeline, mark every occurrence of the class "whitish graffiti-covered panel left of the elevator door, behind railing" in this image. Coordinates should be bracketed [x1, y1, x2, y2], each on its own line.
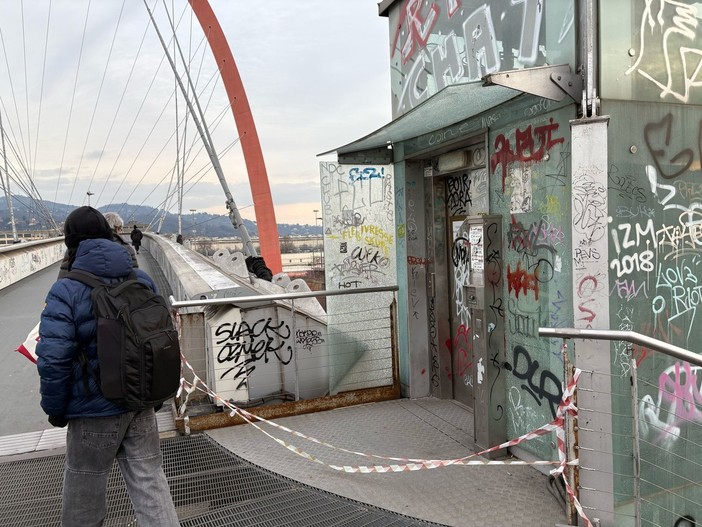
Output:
[320, 163, 397, 394]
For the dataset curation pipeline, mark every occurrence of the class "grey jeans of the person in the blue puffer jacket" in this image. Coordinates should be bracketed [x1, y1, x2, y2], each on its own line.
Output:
[61, 409, 179, 527]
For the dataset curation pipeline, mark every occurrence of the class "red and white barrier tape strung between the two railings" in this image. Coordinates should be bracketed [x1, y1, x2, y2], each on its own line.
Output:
[176, 357, 592, 527]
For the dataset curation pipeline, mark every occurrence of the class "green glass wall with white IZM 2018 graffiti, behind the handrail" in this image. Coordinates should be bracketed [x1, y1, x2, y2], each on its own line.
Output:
[603, 101, 702, 525]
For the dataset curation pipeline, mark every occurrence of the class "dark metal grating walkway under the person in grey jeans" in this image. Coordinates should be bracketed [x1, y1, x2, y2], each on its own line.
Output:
[0, 434, 448, 527]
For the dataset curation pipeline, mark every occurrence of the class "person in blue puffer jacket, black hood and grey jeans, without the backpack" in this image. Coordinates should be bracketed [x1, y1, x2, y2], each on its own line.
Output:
[37, 207, 179, 527]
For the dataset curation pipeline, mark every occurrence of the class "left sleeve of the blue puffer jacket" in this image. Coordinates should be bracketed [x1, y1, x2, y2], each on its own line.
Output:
[37, 281, 76, 417]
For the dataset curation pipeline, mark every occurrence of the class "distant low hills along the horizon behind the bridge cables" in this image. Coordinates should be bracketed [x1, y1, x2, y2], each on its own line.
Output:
[0, 196, 322, 238]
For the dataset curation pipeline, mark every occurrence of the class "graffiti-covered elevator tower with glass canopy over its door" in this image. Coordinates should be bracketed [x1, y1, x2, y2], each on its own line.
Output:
[322, 0, 702, 525]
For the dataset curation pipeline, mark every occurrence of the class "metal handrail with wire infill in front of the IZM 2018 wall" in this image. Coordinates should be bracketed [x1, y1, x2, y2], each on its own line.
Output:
[540, 329, 702, 527]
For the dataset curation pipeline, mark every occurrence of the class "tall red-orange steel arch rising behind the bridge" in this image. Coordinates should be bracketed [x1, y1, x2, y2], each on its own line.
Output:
[188, 0, 283, 274]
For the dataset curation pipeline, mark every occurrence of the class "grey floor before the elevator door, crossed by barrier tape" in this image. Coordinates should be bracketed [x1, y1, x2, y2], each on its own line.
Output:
[208, 399, 566, 527]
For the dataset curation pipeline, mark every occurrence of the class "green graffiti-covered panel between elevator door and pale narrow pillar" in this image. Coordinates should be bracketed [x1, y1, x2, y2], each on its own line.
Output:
[488, 107, 577, 459]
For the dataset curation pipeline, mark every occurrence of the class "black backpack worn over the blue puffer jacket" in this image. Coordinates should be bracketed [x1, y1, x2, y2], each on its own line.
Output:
[66, 270, 180, 410]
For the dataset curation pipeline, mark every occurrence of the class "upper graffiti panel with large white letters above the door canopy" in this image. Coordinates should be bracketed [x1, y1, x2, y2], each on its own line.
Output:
[390, 0, 575, 117]
